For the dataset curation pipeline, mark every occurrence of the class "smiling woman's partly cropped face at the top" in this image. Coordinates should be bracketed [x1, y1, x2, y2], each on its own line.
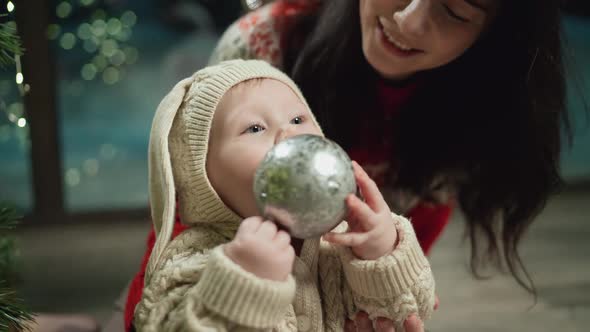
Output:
[359, 0, 500, 79]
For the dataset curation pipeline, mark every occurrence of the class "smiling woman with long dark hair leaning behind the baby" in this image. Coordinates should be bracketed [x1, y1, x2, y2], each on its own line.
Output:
[127, 0, 569, 331]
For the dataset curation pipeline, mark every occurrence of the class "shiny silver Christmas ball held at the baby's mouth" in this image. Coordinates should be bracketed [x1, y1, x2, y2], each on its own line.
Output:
[254, 135, 356, 239]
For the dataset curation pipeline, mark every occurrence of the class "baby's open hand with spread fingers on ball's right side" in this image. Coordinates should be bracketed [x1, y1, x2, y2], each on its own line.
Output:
[324, 161, 397, 260]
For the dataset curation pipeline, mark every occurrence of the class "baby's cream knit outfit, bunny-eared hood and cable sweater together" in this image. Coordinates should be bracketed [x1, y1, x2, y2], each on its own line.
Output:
[134, 60, 434, 332]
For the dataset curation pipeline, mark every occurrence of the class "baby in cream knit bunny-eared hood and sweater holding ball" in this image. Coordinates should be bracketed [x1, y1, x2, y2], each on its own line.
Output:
[134, 60, 434, 332]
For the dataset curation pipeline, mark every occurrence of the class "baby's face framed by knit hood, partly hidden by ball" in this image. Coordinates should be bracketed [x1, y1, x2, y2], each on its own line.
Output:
[207, 79, 322, 218]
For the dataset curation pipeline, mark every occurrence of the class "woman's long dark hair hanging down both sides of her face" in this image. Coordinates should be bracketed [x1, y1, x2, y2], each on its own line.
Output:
[284, 0, 571, 292]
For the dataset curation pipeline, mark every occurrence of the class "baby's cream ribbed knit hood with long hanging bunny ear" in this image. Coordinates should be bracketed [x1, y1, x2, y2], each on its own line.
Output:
[145, 60, 319, 282]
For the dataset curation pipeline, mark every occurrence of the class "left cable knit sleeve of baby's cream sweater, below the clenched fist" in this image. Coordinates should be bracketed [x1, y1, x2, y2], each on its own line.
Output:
[134, 230, 295, 332]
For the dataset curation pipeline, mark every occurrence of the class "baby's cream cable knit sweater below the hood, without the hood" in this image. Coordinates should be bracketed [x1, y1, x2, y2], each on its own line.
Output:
[135, 217, 434, 332]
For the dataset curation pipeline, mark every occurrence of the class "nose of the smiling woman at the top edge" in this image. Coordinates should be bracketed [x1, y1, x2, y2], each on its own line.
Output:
[393, 0, 430, 36]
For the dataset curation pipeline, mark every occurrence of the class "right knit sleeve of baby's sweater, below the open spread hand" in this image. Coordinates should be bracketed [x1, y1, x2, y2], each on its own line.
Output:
[337, 214, 435, 327]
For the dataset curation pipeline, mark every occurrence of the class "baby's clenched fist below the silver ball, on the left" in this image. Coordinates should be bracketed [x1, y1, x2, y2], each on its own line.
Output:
[224, 217, 295, 281]
